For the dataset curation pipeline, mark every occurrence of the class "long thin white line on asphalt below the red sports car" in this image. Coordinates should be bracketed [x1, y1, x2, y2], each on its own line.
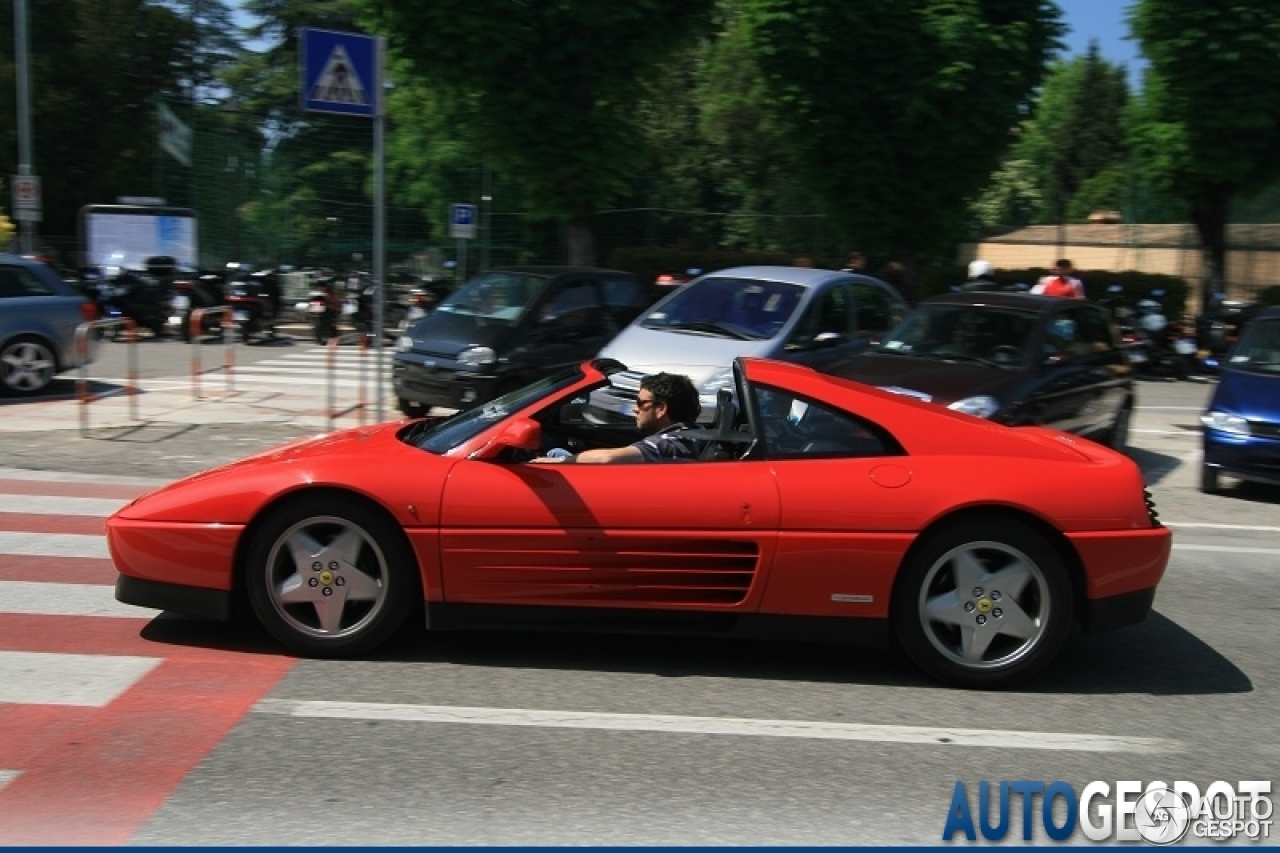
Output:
[255, 699, 1179, 753]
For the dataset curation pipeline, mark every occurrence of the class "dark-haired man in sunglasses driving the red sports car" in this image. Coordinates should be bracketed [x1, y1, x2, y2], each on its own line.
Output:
[532, 373, 701, 464]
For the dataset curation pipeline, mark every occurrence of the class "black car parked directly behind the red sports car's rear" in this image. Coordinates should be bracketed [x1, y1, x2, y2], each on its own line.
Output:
[822, 292, 1135, 450]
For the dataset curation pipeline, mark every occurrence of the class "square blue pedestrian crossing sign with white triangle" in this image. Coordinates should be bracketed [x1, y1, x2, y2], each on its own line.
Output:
[301, 28, 383, 118]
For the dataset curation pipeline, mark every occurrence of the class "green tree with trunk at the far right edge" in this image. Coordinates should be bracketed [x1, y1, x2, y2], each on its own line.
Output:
[1129, 0, 1280, 304]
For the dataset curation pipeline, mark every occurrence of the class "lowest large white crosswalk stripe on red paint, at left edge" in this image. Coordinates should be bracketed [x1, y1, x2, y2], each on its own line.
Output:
[0, 652, 161, 708]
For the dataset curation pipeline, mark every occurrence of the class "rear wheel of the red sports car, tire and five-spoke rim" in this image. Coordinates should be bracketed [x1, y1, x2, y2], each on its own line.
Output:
[892, 521, 1073, 688]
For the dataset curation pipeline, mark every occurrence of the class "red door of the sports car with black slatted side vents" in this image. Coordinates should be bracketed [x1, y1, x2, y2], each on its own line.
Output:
[440, 461, 780, 610]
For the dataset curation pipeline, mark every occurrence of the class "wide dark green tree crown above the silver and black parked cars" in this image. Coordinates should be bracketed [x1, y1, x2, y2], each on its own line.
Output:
[744, 0, 1062, 269]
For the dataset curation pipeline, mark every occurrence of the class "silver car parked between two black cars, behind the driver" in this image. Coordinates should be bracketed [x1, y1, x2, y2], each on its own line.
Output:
[593, 266, 908, 420]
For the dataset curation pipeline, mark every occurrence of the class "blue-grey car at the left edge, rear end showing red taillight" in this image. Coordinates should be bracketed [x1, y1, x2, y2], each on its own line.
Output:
[0, 254, 99, 396]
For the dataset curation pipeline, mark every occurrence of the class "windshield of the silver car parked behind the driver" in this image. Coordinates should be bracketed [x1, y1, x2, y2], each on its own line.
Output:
[640, 277, 804, 341]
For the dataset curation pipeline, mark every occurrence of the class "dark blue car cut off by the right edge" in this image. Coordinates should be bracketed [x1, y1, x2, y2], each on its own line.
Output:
[1201, 306, 1280, 493]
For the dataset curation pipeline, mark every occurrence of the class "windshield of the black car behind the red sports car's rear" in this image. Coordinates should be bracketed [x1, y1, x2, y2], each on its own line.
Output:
[876, 302, 1037, 365]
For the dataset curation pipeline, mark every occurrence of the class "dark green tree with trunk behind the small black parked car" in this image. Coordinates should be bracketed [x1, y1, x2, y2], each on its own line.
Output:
[369, 0, 713, 263]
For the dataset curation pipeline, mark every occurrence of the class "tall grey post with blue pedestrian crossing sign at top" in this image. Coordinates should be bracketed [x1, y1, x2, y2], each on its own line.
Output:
[300, 27, 387, 420]
